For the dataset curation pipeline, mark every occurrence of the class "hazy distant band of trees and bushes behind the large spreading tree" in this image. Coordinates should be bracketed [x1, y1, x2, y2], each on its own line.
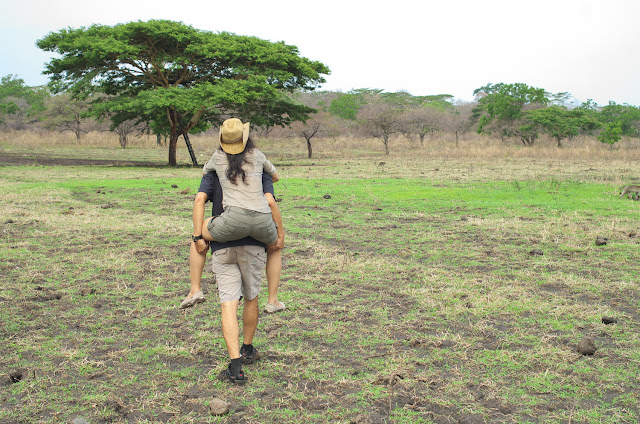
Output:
[0, 75, 640, 158]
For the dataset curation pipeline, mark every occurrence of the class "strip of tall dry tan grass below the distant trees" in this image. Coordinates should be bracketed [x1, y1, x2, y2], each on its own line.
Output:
[0, 130, 640, 161]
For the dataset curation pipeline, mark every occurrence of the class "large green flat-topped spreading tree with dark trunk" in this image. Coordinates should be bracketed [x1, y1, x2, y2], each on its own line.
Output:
[37, 20, 329, 165]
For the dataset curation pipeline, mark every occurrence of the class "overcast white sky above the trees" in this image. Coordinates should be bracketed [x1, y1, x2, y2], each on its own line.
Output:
[0, 0, 640, 105]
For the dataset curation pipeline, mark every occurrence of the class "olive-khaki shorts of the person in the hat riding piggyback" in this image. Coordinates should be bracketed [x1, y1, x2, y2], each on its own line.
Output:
[207, 206, 278, 246]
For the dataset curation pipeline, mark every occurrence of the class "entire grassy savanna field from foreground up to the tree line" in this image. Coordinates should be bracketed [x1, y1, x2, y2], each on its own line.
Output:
[0, 133, 640, 424]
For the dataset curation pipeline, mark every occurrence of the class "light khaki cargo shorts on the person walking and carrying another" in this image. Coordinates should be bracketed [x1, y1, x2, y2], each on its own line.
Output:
[211, 245, 267, 303]
